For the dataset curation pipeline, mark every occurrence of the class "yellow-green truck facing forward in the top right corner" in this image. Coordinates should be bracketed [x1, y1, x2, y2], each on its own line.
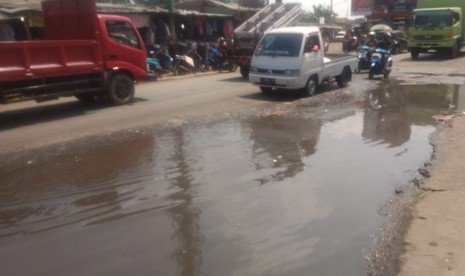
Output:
[408, 0, 465, 59]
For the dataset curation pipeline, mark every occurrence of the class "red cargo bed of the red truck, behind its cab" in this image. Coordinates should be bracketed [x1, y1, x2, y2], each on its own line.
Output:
[0, 40, 103, 103]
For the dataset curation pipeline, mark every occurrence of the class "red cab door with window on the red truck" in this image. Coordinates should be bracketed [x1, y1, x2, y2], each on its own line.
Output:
[98, 15, 147, 79]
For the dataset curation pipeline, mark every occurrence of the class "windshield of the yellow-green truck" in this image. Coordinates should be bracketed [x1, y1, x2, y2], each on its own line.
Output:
[413, 10, 454, 28]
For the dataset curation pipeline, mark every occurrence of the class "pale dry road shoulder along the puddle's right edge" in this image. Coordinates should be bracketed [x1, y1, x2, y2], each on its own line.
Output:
[398, 113, 465, 276]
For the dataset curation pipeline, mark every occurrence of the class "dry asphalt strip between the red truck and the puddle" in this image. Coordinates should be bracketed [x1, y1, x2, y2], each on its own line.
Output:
[0, 72, 266, 154]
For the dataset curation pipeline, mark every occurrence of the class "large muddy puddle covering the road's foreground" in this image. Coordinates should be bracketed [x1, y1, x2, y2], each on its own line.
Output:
[0, 84, 465, 276]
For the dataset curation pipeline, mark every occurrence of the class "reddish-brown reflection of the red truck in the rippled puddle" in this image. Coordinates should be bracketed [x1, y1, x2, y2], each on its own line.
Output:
[0, 136, 154, 236]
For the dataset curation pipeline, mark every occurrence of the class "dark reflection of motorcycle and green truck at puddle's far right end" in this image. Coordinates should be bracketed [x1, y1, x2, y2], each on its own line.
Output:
[362, 83, 465, 147]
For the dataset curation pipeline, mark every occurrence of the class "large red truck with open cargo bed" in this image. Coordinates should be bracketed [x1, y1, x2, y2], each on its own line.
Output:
[0, 0, 147, 105]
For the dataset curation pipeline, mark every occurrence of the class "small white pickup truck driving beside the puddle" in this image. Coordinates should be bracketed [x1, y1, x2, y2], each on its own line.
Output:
[249, 27, 358, 96]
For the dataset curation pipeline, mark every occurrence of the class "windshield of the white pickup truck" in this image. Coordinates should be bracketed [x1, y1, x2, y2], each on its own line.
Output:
[255, 34, 303, 57]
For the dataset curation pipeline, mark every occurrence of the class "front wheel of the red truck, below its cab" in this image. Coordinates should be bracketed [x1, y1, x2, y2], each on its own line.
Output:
[108, 74, 134, 105]
